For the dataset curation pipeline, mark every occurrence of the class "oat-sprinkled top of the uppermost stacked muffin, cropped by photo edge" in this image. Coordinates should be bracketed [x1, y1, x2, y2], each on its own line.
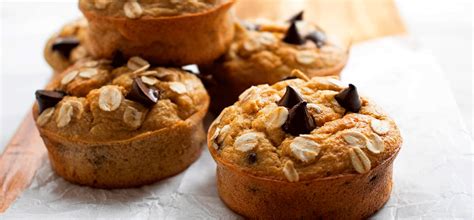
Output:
[79, 0, 224, 19]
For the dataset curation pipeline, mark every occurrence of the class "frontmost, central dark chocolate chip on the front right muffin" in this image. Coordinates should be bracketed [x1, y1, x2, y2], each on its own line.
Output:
[282, 101, 316, 136]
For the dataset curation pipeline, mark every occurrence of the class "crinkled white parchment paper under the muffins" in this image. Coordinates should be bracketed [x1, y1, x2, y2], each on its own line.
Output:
[2, 38, 474, 219]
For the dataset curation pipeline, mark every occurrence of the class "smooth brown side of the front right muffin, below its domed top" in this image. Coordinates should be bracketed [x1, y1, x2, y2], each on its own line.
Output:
[213, 148, 398, 219]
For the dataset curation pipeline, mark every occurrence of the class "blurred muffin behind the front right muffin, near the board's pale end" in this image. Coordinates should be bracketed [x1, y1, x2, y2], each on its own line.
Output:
[200, 13, 348, 112]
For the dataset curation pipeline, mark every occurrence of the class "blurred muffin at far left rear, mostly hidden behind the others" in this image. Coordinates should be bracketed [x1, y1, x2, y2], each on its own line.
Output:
[44, 18, 90, 73]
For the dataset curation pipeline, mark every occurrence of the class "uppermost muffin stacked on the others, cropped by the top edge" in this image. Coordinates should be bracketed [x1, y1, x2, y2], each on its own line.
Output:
[79, 0, 234, 66]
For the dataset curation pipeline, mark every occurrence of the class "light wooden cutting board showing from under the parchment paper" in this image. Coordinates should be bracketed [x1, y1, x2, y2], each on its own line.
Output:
[0, 0, 405, 213]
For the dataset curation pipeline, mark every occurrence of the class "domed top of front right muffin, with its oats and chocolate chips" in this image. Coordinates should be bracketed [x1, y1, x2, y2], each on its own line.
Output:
[208, 74, 402, 182]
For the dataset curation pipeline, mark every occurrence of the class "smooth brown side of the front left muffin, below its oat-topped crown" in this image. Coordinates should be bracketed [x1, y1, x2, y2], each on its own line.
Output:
[33, 102, 206, 189]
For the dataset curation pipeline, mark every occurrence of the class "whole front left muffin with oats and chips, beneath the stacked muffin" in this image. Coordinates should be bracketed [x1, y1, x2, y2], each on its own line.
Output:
[33, 57, 209, 188]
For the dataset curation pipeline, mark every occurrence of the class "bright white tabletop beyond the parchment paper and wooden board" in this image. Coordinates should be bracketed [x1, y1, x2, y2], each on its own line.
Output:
[0, 0, 473, 151]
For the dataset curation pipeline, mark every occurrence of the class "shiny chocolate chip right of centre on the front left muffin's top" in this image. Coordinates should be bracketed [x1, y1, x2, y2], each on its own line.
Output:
[127, 78, 160, 108]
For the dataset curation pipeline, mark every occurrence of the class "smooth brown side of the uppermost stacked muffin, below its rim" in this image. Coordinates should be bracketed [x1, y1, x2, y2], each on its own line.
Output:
[81, 1, 234, 65]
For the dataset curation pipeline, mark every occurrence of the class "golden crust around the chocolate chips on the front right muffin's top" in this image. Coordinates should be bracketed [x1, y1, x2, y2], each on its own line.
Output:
[208, 77, 402, 180]
